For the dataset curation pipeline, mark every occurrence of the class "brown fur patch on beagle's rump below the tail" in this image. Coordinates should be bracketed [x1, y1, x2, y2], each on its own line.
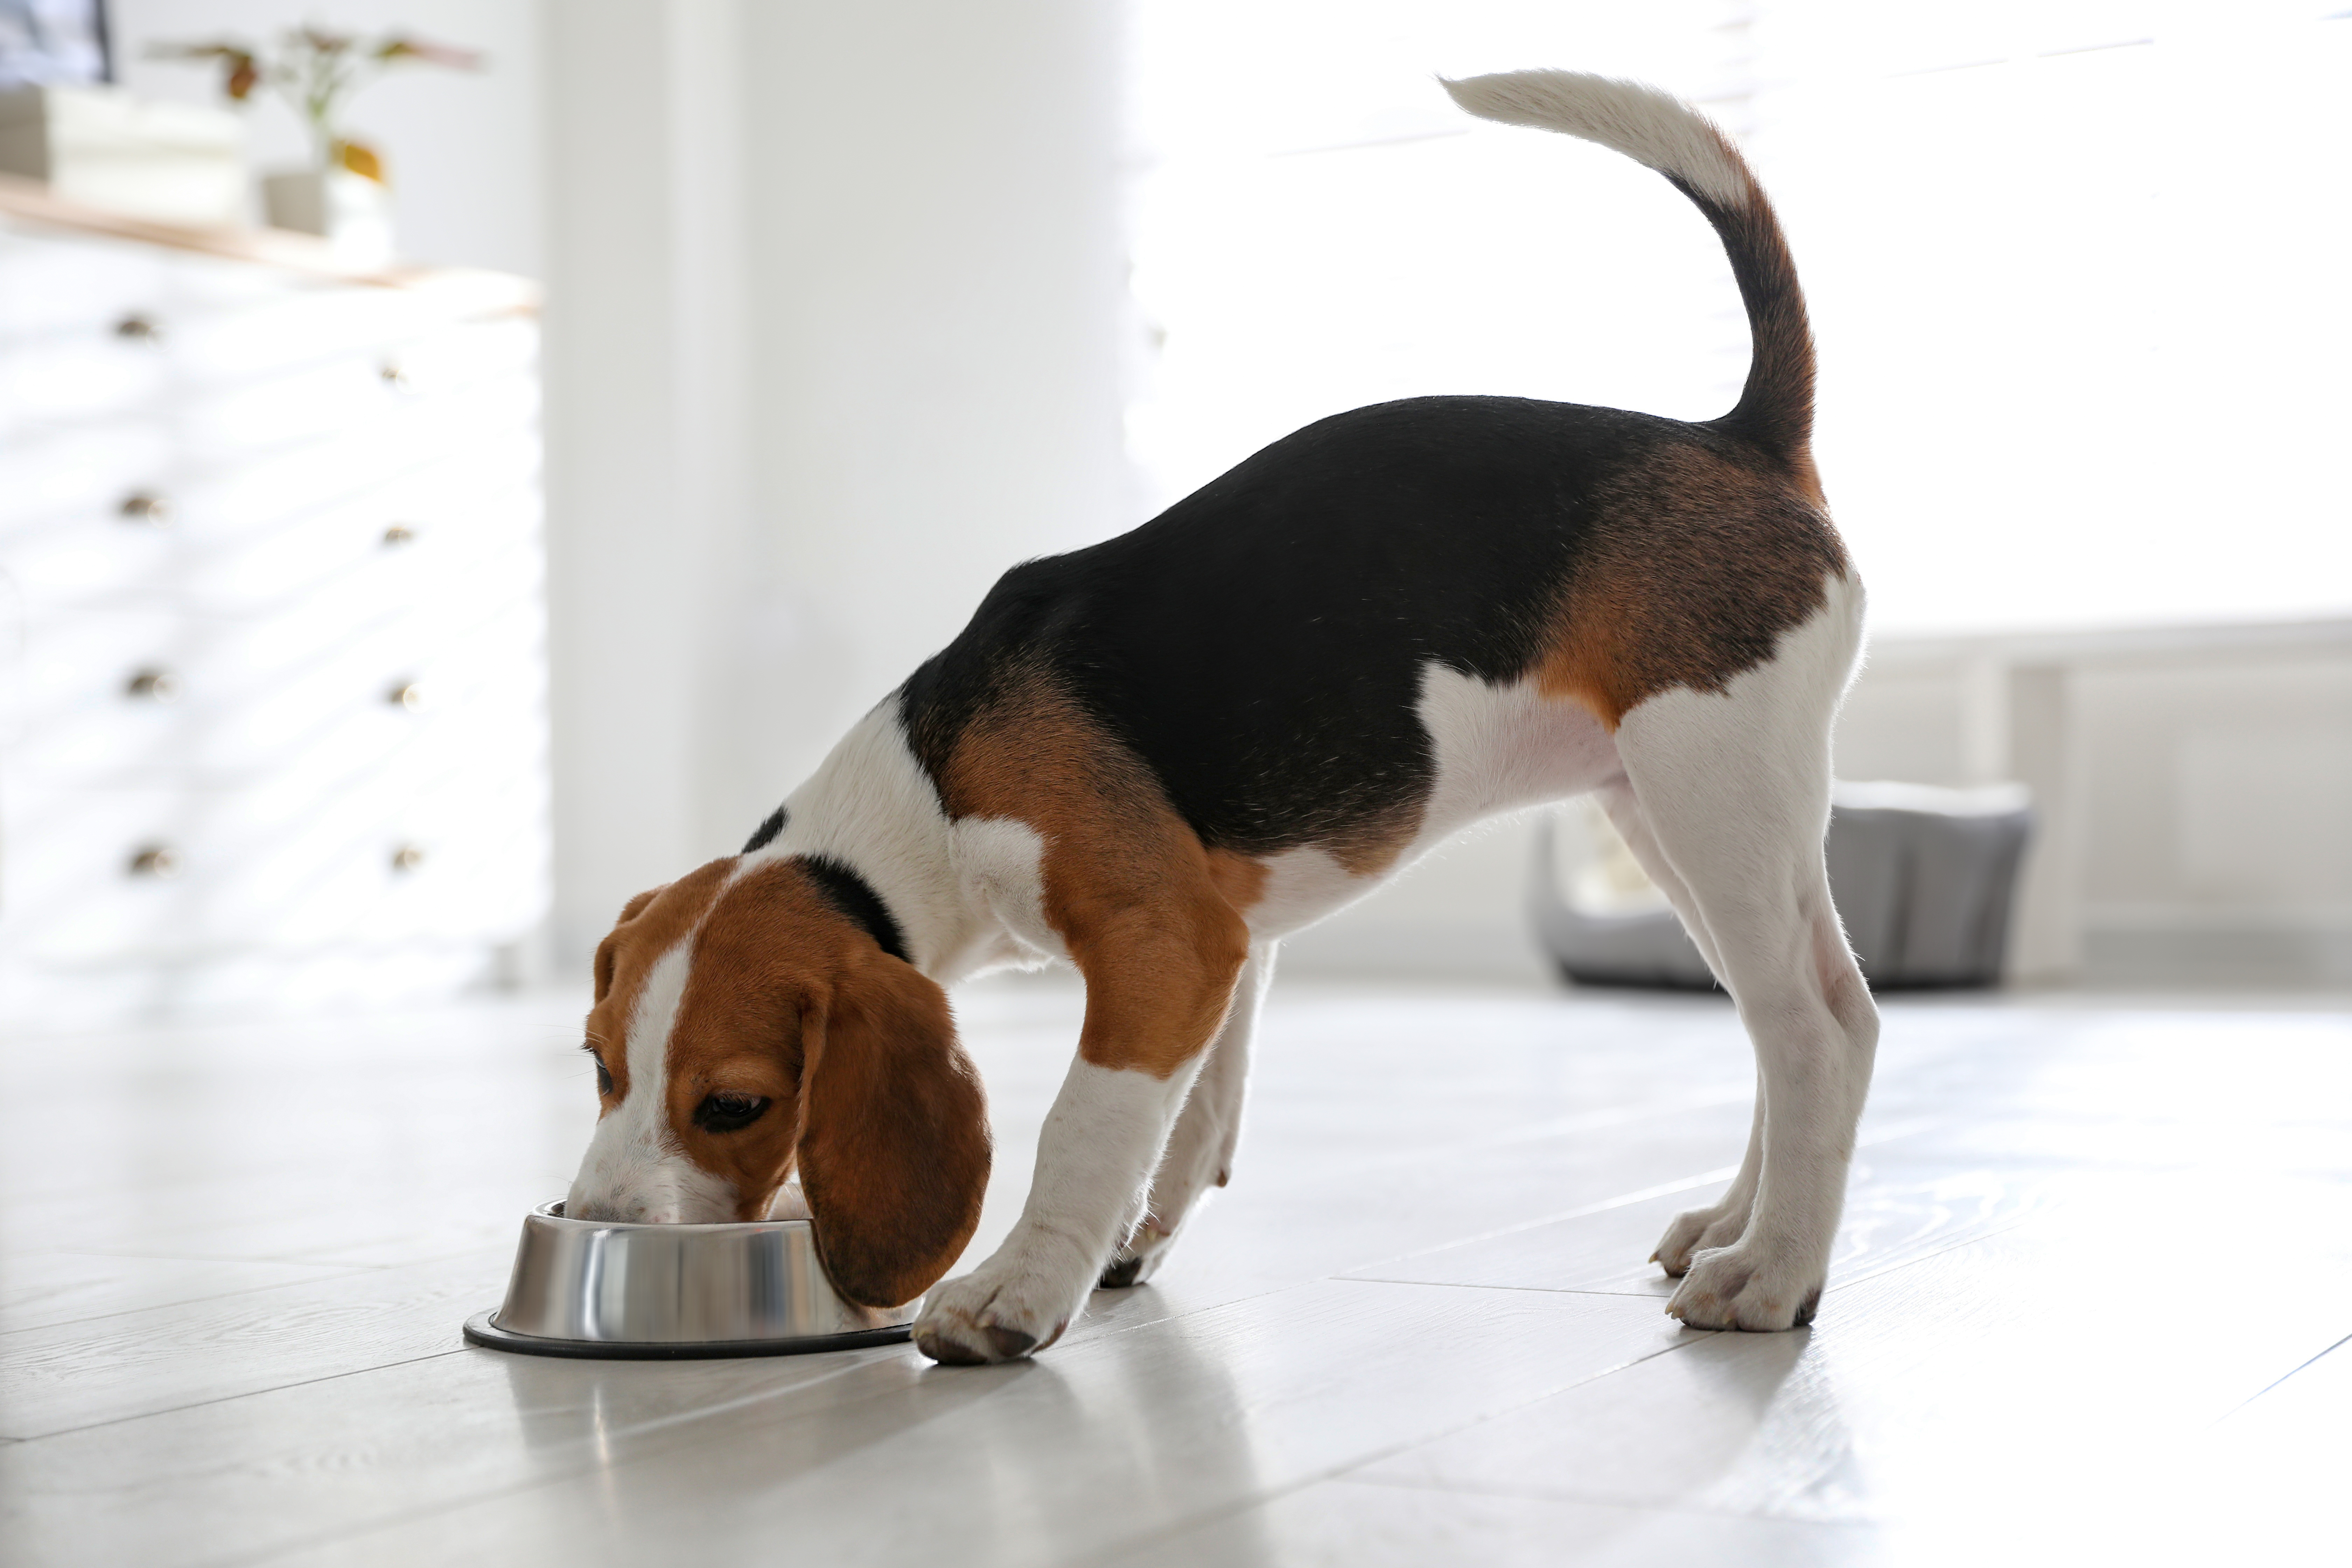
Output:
[1536, 447, 1846, 729]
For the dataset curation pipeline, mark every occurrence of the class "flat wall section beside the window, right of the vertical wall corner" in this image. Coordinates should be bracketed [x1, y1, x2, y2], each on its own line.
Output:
[734, 0, 1141, 804]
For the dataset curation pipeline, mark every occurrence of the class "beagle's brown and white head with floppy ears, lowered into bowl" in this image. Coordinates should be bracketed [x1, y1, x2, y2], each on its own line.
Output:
[565, 858, 988, 1307]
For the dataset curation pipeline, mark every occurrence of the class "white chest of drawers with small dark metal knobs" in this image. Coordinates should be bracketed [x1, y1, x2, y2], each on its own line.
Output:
[0, 193, 548, 1023]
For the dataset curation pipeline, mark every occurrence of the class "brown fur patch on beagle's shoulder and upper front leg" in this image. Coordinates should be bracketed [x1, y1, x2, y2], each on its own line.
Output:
[938, 672, 1265, 1079]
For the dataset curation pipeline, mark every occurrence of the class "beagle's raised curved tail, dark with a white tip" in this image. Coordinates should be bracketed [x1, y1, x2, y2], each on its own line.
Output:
[1444, 70, 1813, 475]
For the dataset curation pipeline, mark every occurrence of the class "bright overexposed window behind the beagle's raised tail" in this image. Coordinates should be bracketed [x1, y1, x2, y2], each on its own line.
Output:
[1129, 0, 2352, 632]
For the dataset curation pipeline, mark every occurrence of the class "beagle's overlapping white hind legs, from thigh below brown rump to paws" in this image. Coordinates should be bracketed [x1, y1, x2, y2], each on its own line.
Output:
[1618, 583, 1877, 1328]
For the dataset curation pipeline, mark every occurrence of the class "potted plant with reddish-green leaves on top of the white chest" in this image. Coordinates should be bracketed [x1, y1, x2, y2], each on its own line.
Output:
[148, 26, 482, 266]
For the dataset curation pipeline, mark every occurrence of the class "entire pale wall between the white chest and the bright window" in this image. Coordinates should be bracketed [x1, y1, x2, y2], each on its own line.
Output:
[546, 0, 1136, 959]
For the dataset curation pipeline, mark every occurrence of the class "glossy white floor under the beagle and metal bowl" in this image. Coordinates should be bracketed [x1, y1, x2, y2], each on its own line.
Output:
[0, 983, 2352, 1568]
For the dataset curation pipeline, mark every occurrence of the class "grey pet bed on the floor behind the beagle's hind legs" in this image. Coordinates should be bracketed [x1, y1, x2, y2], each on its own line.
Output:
[1529, 783, 2035, 990]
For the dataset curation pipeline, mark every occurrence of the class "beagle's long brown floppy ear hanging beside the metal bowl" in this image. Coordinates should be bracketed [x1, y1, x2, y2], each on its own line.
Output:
[800, 952, 988, 1307]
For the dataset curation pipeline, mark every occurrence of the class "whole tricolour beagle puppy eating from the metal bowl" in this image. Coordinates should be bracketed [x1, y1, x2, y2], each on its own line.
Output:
[569, 70, 1877, 1361]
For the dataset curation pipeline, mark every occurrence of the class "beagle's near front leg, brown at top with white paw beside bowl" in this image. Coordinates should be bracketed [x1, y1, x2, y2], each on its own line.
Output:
[915, 905, 1247, 1364]
